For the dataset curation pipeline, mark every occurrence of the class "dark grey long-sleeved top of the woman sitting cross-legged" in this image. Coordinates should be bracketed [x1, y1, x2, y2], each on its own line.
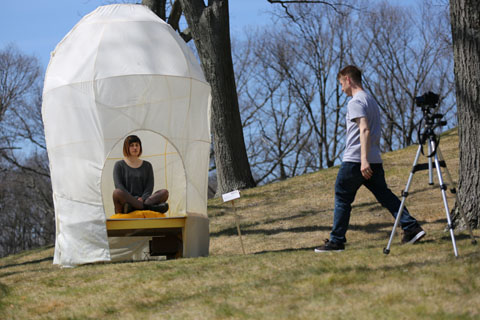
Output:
[113, 160, 153, 200]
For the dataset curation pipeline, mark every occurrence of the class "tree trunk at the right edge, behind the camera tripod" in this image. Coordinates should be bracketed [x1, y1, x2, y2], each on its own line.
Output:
[450, 0, 480, 228]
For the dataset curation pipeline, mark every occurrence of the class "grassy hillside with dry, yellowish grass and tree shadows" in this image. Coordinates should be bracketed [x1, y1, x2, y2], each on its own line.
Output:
[0, 130, 480, 319]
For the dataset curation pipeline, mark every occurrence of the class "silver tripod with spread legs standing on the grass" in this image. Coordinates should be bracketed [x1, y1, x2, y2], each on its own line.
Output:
[383, 122, 477, 257]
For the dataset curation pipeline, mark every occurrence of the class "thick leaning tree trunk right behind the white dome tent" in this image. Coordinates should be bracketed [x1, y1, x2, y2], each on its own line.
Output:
[181, 0, 255, 195]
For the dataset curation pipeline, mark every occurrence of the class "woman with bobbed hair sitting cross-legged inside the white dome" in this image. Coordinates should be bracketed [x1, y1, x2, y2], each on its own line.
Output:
[113, 135, 168, 213]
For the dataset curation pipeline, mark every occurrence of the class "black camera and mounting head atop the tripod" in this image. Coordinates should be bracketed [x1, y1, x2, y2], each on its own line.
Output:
[415, 91, 447, 158]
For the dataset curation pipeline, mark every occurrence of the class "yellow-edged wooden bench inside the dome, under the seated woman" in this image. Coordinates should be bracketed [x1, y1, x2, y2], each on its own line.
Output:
[107, 217, 186, 259]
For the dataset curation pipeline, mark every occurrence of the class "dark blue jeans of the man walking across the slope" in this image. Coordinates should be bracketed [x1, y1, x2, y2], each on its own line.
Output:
[330, 162, 418, 243]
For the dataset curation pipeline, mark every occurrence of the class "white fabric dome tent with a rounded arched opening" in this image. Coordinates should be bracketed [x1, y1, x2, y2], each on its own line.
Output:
[42, 4, 211, 266]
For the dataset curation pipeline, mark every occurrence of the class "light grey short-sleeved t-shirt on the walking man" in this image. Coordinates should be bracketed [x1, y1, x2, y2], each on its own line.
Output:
[342, 90, 382, 163]
